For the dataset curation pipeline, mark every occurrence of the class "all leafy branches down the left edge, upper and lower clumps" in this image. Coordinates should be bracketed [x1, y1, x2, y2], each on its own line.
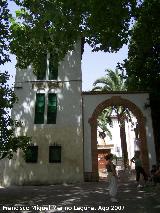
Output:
[0, 0, 30, 159]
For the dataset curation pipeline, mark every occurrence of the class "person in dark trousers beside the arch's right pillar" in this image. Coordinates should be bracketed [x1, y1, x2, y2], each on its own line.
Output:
[131, 151, 148, 187]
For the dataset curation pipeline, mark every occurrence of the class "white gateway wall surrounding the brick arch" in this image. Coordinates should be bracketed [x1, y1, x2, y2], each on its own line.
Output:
[83, 92, 156, 172]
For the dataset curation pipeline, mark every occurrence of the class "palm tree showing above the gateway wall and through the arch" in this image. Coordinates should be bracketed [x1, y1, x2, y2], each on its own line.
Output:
[92, 69, 131, 168]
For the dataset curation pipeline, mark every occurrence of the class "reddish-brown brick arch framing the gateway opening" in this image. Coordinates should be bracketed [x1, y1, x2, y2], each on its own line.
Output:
[89, 96, 149, 181]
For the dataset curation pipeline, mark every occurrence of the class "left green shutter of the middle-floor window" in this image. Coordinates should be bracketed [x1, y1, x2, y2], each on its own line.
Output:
[34, 93, 45, 124]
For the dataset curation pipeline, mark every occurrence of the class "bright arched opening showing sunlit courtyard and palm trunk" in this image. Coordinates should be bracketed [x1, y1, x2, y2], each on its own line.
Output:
[97, 105, 137, 180]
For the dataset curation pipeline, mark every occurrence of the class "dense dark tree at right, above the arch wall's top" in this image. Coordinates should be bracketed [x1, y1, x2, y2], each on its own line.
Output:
[124, 0, 160, 93]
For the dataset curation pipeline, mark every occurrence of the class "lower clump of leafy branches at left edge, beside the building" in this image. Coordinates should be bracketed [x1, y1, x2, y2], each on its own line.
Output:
[0, 72, 30, 159]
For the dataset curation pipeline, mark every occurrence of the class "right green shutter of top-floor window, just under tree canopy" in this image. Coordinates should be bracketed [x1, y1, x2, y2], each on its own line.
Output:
[49, 54, 58, 80]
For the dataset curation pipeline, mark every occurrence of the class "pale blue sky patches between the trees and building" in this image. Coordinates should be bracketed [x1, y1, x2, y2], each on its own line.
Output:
[1, 1, 128, 91]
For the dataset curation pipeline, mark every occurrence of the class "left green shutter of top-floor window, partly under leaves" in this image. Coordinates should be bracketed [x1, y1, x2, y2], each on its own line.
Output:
[36, 54, 47, 80]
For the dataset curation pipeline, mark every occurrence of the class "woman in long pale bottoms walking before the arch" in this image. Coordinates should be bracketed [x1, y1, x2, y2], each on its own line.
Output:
[105, 153, 118, 202]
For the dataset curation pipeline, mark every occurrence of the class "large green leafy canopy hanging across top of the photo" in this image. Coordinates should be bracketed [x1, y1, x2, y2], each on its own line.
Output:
[10, 0, 137, 72]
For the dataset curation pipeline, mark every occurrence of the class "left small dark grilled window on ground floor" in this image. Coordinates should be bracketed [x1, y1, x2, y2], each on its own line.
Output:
[25, 146, 38, 163]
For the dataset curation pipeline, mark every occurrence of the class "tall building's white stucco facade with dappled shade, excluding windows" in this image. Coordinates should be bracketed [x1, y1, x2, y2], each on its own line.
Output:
[3, 43, 83, 185]
